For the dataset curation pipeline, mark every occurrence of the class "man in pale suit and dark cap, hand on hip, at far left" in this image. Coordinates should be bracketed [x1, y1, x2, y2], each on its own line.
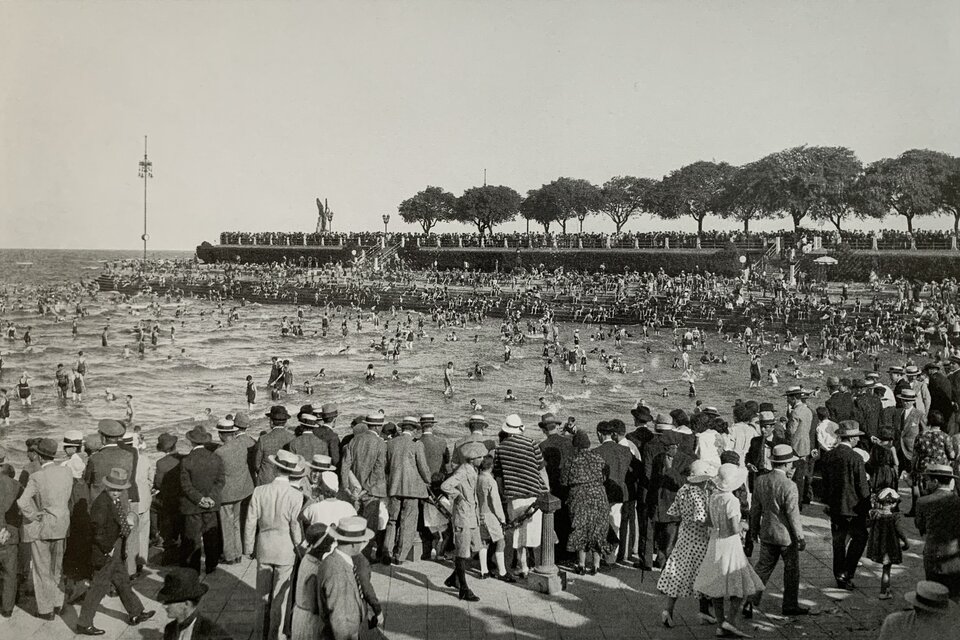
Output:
[17, 438, 73, 620]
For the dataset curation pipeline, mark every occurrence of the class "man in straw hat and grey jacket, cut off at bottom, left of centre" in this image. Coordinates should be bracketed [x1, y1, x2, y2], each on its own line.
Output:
[317, 516, 380, 640]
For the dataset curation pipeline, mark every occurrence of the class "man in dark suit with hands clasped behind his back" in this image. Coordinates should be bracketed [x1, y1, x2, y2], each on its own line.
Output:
[180, 425, 226, 573]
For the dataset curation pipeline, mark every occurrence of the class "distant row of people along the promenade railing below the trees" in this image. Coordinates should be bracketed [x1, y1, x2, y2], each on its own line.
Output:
[220, 228, 953, 250]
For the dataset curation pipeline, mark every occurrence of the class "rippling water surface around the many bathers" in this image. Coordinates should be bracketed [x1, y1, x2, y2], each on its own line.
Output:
[0, 250, 773, 461]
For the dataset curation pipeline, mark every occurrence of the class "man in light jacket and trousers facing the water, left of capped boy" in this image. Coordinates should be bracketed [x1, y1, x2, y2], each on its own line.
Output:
[381, 416, 431, 564]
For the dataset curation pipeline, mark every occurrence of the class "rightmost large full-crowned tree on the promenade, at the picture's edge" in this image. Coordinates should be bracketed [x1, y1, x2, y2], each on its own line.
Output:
[863, 149, 954, 233]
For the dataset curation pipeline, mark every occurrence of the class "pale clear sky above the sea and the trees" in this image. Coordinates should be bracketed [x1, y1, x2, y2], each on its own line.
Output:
[0, 0, 960, 249]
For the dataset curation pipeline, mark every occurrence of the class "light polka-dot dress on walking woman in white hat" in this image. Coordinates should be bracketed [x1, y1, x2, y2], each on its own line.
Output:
[657, 483, 710, 598]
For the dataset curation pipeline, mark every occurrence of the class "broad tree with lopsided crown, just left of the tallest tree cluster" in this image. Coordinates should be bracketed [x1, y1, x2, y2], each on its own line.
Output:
[650, 160, 734, 236]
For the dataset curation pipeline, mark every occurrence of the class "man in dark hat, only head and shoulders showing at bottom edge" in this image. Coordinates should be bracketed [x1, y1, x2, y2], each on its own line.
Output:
[157, 567, 233, 640]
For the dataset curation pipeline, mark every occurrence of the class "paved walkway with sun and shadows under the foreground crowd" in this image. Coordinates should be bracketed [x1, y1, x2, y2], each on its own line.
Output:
[0, 505, 922, 640]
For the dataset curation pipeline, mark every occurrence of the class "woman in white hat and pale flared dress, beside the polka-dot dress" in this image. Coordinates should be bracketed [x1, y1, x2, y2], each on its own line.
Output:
[693, 464, 763, 638]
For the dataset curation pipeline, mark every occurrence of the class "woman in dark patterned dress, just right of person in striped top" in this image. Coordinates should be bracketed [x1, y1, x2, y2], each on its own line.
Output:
[560, 431, 611, 575]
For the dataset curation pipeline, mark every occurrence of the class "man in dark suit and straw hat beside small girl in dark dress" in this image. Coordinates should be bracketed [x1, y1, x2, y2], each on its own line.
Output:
[823, 420, 870, 591]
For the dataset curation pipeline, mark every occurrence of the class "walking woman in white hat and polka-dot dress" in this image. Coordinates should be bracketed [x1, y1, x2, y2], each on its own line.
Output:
[657, 460, 716, 627]
